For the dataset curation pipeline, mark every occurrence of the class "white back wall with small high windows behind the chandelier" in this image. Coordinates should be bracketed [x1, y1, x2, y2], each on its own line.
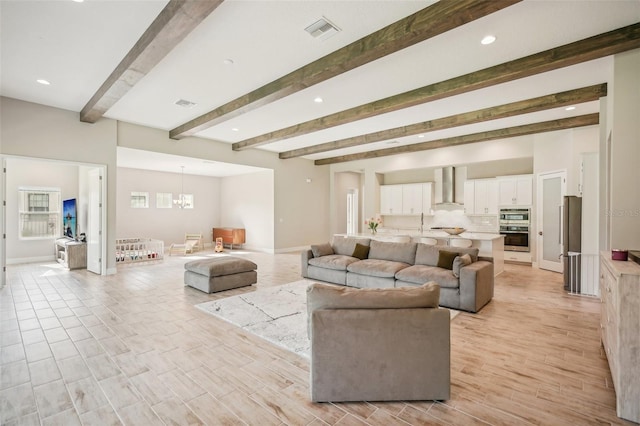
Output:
[116, 167, 220, 248]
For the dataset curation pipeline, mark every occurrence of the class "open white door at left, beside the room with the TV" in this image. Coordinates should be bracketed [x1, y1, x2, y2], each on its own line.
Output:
[87, 168, 102, 274]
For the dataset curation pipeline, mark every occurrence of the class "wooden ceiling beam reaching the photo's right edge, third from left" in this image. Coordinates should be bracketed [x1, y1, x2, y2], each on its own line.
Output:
[238, 23, 640, 151]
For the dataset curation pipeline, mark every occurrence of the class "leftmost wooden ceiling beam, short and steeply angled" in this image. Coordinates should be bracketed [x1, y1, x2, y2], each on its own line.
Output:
[80, 0, 223, 123]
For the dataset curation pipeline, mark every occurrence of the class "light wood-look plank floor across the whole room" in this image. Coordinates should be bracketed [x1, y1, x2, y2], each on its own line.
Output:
[0, 251, 630, 426]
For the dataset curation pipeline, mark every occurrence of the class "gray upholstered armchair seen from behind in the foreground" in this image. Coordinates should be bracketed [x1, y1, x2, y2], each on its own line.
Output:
[307, 283, 451, 402]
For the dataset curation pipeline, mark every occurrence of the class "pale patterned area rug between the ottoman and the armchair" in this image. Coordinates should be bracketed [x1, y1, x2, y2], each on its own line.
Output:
[196, 280, 460, 359]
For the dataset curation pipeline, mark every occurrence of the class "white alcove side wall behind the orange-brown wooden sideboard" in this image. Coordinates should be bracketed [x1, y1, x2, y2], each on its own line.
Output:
[216, 170, 274, 252]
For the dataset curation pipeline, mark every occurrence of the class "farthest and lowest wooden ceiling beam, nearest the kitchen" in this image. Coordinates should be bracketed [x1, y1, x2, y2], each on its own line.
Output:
[314, 113, 600, 166]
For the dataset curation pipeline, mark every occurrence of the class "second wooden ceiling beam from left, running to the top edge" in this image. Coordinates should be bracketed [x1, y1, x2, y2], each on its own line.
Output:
[169, 0, 521, 139]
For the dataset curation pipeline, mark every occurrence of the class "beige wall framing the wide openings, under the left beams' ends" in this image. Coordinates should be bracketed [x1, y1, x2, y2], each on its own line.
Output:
[0, 97, 329, 258]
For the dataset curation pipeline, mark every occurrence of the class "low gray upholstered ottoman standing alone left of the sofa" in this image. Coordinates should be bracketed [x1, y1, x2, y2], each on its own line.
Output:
[184, 256, 258, 293]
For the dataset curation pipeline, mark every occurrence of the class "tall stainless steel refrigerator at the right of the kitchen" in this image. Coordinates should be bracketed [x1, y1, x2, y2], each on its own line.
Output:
[562, 195, 582, 293]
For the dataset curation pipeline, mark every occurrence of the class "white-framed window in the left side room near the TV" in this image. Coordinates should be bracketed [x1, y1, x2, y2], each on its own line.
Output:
[18, 187, 62, 239]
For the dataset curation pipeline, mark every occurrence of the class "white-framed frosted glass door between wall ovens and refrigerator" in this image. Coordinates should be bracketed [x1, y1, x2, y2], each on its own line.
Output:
[537, 172, 566, 272]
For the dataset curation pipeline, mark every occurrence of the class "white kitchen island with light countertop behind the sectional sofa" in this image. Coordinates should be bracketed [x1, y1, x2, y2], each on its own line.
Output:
[334, 230, 504, 275]
